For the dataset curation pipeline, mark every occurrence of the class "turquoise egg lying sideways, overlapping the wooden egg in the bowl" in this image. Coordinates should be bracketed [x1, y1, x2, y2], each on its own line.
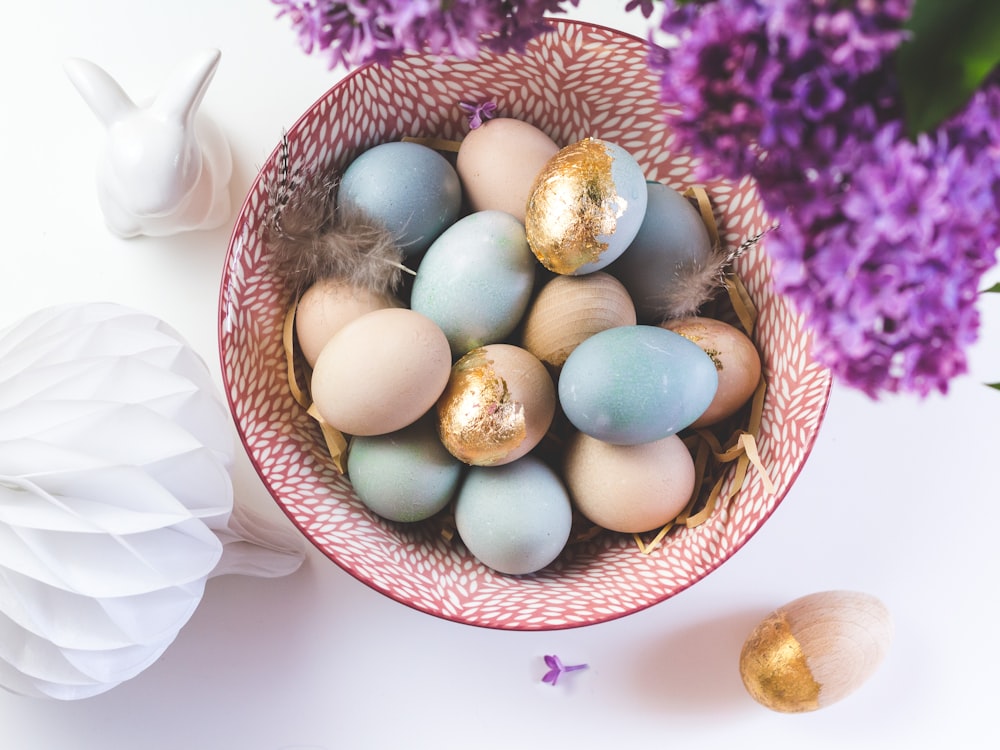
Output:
[558, 325, 719, 445]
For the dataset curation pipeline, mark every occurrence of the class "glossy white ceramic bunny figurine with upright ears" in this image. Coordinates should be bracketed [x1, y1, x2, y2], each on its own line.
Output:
[65, 49, 233, 237]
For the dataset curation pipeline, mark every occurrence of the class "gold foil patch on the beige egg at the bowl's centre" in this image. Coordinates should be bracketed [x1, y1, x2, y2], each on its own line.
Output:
[437, 347, 527, 466]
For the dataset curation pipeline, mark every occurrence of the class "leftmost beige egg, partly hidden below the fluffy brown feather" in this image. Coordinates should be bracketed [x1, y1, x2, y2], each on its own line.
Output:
[295, 279, 399, 367]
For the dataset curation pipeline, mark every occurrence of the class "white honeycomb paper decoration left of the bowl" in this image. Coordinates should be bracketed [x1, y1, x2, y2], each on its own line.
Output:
[0, 303, 303, 700]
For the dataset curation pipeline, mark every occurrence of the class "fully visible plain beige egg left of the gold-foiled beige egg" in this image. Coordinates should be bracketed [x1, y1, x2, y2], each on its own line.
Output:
[310, 307, 451, 435]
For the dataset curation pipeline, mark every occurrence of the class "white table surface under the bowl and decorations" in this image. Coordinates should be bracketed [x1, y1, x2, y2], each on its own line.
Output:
[0, 0, 1000, 750]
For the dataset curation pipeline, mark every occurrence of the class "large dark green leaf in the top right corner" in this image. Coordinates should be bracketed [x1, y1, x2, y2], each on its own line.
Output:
[896, 0, 1000, 136]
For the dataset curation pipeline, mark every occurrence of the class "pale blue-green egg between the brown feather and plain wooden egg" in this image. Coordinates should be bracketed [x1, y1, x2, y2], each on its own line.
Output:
[410, 211, 538, 356]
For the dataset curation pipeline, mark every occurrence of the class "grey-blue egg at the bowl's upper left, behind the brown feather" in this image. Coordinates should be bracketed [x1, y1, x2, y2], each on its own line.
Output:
[337, 141, 462, 258]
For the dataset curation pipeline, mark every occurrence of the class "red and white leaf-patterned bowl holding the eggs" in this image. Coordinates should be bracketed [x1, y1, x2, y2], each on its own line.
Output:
[219, 21, 830, 630]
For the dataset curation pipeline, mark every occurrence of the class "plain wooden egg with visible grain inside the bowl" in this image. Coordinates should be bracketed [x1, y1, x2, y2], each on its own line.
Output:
[522, 271, 636, 368]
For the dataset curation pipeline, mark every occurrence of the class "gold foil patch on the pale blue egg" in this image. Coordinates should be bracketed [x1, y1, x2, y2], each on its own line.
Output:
[524, 138, 626, 274]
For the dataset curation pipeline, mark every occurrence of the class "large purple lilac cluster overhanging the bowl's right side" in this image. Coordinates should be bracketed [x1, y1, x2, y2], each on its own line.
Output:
[652, 0, 1000, 397]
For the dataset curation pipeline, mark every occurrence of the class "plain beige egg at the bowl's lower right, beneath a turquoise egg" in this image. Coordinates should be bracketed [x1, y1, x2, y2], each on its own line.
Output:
[563, 432, 695, 533]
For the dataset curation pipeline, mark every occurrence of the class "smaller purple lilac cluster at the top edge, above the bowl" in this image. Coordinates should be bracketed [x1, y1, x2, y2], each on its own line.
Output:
[272, 0, 578, 68]
